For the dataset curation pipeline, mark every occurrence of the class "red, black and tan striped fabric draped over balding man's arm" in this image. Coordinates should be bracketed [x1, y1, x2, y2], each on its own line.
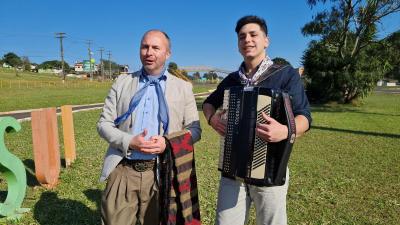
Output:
[159, 132, 201, 225]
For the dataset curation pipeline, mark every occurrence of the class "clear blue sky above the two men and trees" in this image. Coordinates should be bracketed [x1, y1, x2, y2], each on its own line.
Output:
[0, 0, 400, 70]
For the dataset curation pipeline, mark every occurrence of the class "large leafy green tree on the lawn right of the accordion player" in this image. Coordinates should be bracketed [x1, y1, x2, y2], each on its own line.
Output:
[302, 0, 400, 103]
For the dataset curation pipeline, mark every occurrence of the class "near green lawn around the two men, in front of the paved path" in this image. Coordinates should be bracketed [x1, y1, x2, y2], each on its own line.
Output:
[0, 89, 400, 225]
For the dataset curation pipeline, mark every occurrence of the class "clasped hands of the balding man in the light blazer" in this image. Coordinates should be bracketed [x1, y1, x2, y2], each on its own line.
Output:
[129, 129, 166, 154]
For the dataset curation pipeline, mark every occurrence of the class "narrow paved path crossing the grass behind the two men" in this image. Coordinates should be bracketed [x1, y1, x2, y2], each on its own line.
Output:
[0, 92, 210, 121]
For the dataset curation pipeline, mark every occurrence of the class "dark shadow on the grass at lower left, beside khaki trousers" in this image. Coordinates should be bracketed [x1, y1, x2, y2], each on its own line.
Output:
[33, 189, 101, 225]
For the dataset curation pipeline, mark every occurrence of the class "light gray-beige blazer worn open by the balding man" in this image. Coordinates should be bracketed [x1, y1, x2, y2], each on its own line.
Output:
[97, 71, 199, 181]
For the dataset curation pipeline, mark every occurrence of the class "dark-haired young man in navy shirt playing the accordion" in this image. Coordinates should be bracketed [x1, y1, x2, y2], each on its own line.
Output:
[203, 16, 311, 225]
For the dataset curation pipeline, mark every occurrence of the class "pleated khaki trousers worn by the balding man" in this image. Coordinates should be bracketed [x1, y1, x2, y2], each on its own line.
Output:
[101, 164, 159, 225]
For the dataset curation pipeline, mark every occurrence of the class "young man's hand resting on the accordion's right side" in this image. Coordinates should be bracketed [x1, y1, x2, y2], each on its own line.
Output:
[256, 112, 289, 142]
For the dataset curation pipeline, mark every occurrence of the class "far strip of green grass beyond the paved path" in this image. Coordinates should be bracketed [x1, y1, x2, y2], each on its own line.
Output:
[0, 69, 216, 112]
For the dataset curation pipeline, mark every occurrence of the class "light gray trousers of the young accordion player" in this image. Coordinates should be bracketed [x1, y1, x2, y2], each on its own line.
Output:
[215, 170, 289, 225]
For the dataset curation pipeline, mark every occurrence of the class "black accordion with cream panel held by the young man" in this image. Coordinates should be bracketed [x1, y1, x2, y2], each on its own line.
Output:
[218, 87, 296, 186]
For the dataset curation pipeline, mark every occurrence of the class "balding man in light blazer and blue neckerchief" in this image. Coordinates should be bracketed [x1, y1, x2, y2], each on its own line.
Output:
[97, 30, 201, 225]
